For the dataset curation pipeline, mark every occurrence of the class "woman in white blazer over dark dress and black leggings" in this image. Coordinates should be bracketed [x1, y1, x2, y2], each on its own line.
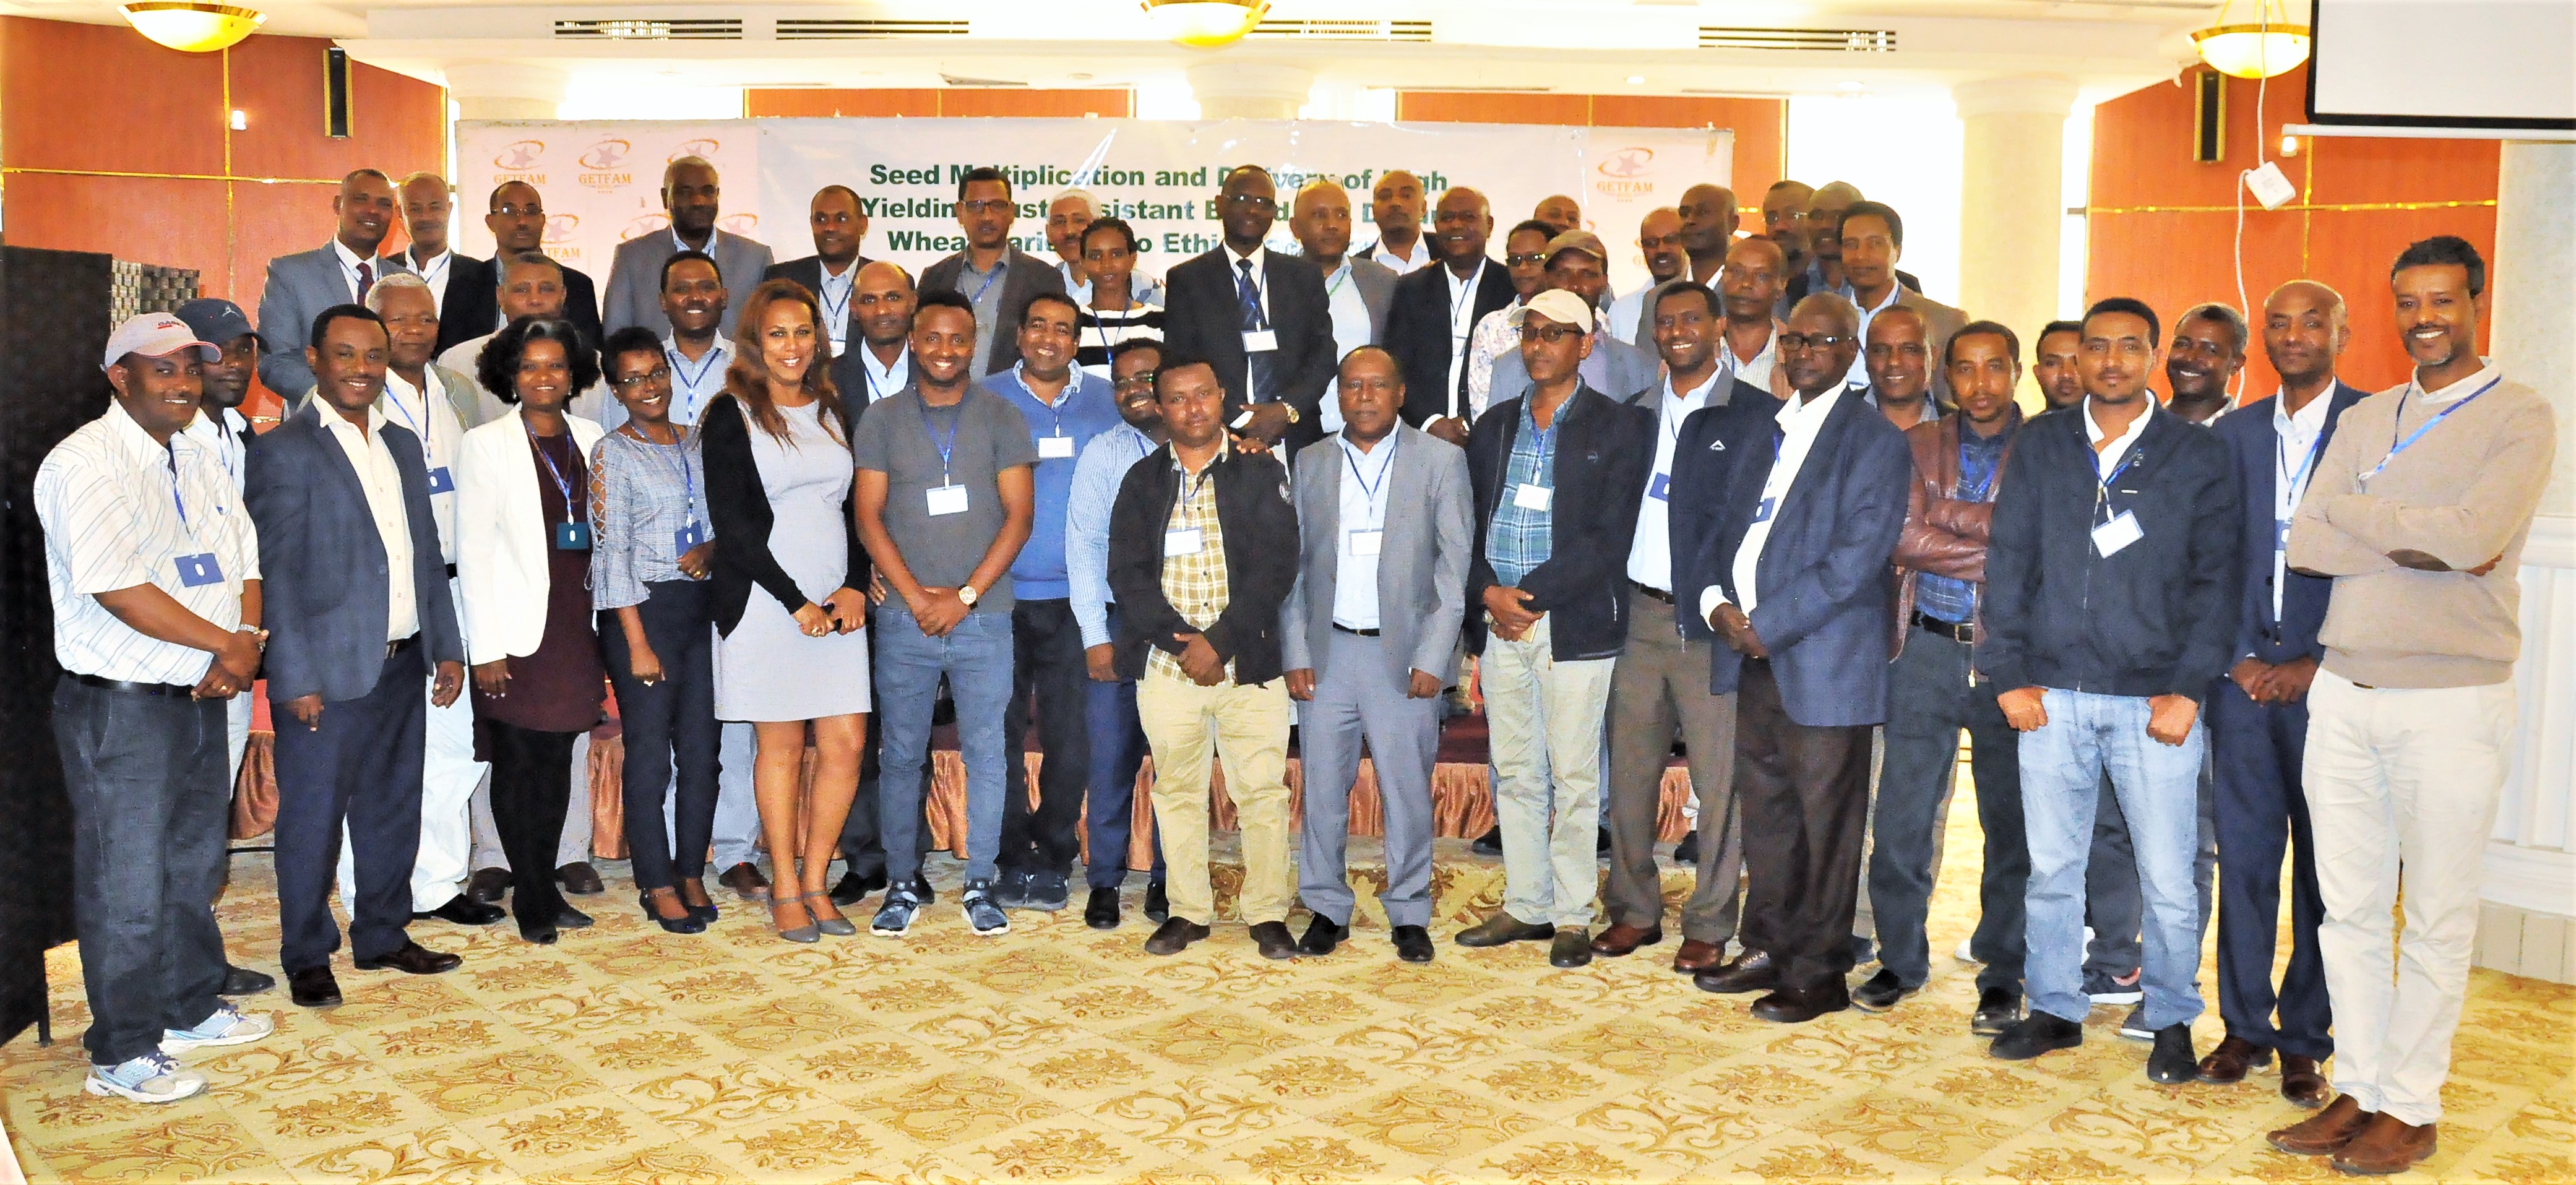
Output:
[456, 319, 608, 943]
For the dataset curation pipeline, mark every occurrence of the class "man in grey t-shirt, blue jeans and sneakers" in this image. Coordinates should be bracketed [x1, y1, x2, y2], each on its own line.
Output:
[850, 291, 1038, 935]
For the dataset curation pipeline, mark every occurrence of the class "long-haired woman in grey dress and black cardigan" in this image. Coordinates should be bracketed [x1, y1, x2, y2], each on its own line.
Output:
[698, 281, 868, 943]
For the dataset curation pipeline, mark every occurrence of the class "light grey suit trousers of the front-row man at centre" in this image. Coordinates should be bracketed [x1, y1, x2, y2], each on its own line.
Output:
[1296, 629, 1440, 925]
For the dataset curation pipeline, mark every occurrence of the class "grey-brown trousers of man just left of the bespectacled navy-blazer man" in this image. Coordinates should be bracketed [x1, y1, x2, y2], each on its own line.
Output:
[1602, 587, 1744, 946]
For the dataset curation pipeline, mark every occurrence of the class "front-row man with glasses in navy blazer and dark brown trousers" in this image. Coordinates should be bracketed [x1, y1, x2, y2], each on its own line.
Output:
[1674, 294, 1914, 1023]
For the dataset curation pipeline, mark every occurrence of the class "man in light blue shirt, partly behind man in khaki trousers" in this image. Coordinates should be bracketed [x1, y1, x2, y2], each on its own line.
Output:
[1064, 337, 1170, 930]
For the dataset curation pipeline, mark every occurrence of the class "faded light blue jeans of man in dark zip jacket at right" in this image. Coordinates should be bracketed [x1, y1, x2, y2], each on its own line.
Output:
[2022, 688, 2208, 1028]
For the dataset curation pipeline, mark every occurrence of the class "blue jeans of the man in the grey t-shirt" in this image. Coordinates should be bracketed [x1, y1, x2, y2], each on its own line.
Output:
[873, 600, 1017, 884]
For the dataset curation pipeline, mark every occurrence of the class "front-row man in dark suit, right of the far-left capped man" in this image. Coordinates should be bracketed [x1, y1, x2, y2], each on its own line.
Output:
[244, 304, 463, 1007]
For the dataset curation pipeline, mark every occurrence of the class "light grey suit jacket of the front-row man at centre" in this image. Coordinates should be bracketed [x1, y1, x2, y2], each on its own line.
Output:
[1280, 423, 1476, 685]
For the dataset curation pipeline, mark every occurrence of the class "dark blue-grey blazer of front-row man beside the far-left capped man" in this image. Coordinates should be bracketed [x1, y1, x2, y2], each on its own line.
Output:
[242, 402, 467, 704]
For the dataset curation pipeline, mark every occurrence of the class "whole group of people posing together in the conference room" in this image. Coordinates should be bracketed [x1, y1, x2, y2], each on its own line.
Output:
[36, 157, 2556, 1172]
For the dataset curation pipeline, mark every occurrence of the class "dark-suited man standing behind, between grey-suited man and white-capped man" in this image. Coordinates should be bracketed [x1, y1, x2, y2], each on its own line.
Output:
[1384, 186, 1520, 446]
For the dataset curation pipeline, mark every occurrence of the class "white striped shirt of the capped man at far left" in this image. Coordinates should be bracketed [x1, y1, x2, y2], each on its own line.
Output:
[36, 402, 260, 685]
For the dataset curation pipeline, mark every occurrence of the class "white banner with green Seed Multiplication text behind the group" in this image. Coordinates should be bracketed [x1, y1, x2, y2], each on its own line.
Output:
[456, 119, 1734, 291]
